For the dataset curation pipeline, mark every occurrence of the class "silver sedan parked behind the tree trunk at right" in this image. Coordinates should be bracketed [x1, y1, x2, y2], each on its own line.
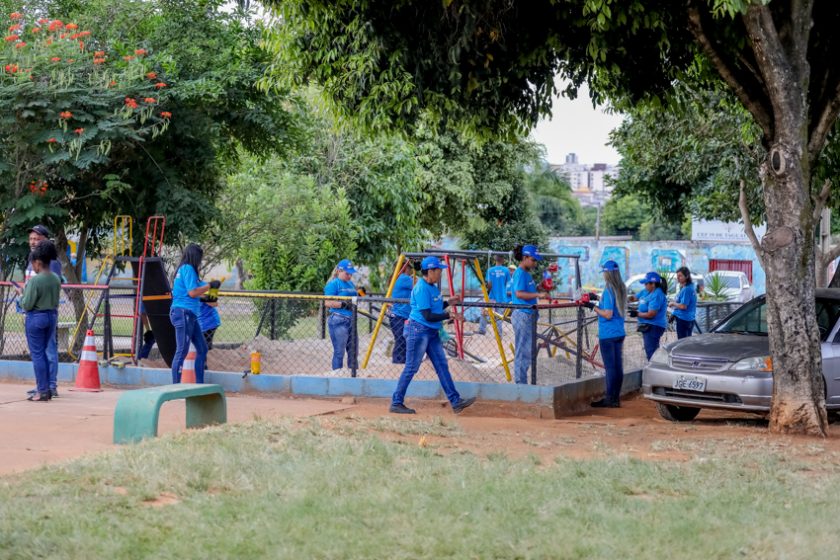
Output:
[642, 289, 840, 422]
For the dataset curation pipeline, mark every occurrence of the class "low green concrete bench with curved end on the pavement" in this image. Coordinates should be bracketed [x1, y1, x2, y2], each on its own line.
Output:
[114, 383, 227, 443]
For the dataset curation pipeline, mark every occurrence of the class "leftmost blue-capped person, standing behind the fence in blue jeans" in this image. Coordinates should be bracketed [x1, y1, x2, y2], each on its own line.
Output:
[324, 259, 358, 371]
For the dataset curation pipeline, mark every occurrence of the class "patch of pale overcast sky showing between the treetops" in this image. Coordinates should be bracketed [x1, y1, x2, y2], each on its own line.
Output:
[533, 86, 622, 164]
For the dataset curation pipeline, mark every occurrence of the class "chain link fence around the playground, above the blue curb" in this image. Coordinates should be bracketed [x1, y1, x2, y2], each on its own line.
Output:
[0, 282, 740, 385]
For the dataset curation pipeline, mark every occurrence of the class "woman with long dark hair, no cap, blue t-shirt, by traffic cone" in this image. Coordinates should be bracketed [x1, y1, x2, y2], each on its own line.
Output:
[169, 243, 221, 383]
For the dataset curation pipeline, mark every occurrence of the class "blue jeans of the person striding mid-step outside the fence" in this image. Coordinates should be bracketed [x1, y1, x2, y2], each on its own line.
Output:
[391, 321, 461, 406]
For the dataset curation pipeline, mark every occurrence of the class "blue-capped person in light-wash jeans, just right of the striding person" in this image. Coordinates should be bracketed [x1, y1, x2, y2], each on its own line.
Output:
[510, 245, 543, 383]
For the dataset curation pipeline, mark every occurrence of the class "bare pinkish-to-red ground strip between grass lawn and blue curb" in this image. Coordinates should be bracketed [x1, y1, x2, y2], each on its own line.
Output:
[0, 376, 840, 475]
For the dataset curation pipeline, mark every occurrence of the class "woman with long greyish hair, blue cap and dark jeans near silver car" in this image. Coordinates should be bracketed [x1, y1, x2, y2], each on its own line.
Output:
[587, 261, 627, 408]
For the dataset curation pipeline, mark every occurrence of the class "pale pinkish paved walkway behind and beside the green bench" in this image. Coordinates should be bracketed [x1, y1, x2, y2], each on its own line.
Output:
[0, 383, 352, 475]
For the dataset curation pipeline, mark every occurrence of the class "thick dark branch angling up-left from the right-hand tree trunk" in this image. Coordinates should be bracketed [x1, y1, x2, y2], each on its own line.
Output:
[688, 0, 773, 138]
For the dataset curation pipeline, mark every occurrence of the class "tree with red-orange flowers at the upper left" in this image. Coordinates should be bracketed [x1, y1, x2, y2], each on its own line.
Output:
[0, 12, 172, 269]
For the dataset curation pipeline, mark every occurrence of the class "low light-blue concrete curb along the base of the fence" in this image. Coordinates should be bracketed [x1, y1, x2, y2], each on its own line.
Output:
[0, 360, 641, 418]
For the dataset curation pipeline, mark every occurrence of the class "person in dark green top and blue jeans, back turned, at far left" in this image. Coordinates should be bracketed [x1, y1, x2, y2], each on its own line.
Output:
[17, 241, 61, 402]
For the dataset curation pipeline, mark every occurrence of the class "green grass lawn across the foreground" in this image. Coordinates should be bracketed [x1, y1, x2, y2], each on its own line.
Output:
[0, 419, 840, 560]
